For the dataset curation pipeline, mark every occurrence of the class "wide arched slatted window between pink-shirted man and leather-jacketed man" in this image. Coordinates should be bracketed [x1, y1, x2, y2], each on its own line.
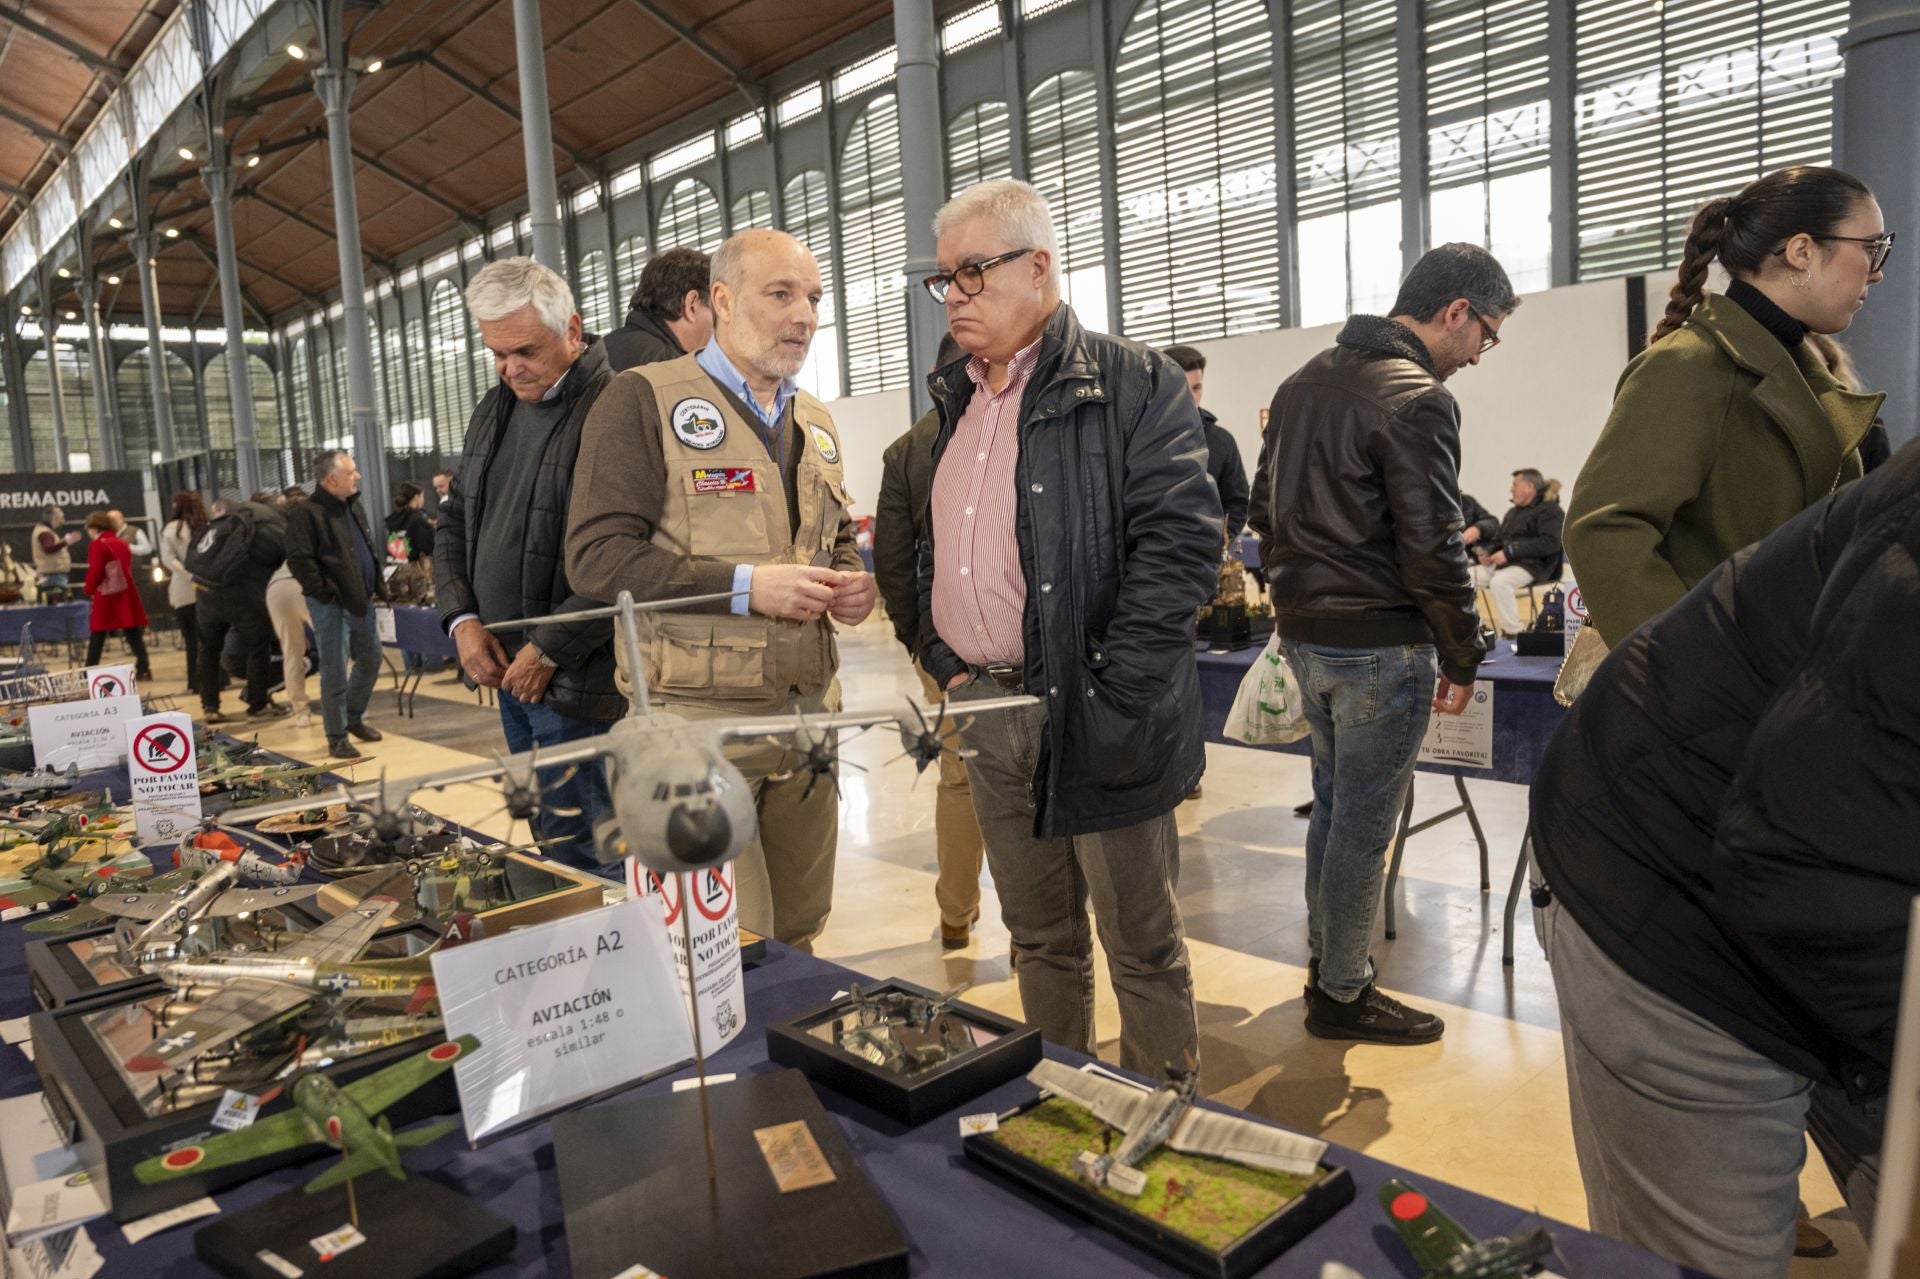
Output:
[1114, 0, 1274, 346]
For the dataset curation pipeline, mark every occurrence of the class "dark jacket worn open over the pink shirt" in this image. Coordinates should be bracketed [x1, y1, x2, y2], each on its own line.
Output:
[920, 305, 1221, 837]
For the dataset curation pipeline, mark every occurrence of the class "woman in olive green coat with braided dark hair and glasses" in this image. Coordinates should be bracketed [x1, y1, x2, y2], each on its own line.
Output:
[1567, 167, 1893, 645]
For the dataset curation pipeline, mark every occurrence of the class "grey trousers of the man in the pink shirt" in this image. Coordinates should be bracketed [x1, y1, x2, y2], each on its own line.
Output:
[952, 680, 1200, 1079]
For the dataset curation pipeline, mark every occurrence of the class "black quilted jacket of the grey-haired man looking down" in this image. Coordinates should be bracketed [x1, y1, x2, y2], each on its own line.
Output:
[434, 342, 626, 724]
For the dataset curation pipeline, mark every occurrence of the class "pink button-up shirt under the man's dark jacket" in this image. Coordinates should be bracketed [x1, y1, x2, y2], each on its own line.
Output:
[931, 338, 1041, 666]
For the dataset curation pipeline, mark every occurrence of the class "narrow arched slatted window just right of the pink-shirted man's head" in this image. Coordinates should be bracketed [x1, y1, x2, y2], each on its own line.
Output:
[1027, 71, 1112, 332]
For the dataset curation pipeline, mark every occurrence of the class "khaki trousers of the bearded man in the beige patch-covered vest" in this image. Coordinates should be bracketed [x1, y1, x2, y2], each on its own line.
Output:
[653, 680, 841, 953]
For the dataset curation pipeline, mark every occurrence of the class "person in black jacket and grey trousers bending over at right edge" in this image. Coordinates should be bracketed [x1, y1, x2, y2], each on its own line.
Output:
[1532, 444, 1920, 1275]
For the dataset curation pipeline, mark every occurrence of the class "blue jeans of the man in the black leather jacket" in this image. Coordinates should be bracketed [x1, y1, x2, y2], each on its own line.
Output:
[1281, 640, 1434, 1002]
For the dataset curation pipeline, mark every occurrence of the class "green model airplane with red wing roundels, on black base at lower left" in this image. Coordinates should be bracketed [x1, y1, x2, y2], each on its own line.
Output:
[132, 1035, 480, 1195]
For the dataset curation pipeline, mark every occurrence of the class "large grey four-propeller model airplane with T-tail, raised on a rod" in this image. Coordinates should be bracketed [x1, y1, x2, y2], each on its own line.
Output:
[219, 591, 1037, 874]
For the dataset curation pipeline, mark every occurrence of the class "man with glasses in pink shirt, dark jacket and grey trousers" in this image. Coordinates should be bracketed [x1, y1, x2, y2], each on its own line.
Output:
[920, 181, 1223, 1075]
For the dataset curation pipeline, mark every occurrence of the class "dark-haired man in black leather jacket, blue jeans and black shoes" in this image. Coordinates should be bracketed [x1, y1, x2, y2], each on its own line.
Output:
[1254, 244, 1519, 1045]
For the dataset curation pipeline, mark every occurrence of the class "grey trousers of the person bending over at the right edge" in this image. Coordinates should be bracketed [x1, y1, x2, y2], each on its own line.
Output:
[1546, 903, 1878, 1279]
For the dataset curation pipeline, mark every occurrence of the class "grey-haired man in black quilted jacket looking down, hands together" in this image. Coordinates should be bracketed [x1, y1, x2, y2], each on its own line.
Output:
[434, 257, 626, 868]
